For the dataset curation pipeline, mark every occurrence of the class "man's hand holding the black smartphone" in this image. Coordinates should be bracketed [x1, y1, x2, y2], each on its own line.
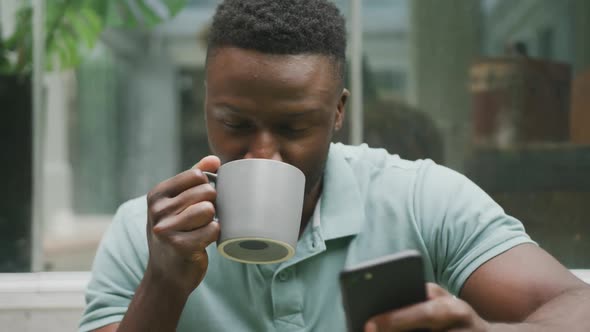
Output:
[365, 283, 489, 332]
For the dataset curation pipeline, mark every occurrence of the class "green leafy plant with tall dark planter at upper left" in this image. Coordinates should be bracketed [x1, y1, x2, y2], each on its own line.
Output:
[0, 0, 186, 272]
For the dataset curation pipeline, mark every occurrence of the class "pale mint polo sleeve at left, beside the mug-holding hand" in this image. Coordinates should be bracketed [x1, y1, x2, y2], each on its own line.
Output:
[79, 197, 148, 331]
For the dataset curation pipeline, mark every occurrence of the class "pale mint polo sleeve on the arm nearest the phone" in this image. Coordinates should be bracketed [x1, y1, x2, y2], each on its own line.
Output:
[414, 161, 534, 294]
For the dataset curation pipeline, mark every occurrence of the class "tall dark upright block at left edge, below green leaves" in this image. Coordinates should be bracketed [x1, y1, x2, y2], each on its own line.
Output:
[0, 75, 33, 272]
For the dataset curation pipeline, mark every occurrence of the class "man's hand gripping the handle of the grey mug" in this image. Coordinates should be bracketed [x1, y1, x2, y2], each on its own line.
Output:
[146, 156, 220, 295]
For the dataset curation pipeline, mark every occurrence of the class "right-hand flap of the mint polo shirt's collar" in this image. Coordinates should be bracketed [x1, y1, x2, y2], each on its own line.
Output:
[320, 144, 365, 240]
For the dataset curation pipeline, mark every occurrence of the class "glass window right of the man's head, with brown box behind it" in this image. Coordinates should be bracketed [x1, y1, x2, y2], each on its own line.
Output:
[353, 0, 590, 268]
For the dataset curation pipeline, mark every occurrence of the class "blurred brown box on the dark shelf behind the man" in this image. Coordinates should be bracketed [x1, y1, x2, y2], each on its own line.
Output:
[470, 56, 571, 146]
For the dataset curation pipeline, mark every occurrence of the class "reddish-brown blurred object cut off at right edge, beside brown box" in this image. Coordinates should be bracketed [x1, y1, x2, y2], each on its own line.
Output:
[570, 70, 590, 144]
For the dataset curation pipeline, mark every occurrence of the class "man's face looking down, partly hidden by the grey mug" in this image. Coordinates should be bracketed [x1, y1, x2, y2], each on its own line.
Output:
[205, 47, 348, 194]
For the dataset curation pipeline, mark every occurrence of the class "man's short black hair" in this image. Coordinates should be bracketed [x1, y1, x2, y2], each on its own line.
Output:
[207, 0, 346, 79]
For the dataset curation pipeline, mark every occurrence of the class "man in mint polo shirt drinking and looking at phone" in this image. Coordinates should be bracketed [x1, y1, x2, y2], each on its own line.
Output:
[81, 0, 590, 331]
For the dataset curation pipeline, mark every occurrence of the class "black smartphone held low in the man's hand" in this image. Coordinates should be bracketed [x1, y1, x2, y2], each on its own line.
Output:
[340, 250, 426, 332]
